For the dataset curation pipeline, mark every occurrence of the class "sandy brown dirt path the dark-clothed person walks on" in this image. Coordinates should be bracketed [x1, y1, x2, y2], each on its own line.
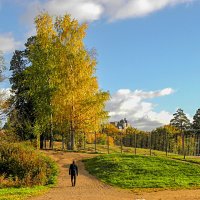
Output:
[29, 151, 200, 200]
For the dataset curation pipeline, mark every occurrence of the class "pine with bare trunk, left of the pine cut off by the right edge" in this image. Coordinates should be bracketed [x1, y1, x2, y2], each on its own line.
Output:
[170, 108, 191, 159]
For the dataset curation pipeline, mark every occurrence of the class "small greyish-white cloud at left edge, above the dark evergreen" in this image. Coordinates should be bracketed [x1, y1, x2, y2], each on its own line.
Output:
[0, 33, 21, 53]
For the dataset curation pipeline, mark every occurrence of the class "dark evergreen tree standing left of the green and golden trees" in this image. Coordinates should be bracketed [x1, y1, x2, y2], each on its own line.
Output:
[8, 38, 35, 140]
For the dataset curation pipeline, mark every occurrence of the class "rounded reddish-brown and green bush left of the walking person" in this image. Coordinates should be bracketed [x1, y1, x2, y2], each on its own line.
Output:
[0, 141, 57, 188]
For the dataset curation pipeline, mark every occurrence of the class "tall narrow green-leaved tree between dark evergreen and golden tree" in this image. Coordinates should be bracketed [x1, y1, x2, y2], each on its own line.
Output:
[25, 30, 54, 148]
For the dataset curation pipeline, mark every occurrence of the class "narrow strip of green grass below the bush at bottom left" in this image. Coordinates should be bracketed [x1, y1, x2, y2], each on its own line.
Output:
[0, 186, 50, 200]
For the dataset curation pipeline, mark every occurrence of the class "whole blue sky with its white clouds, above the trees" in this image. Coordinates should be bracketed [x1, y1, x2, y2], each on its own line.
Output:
[0, 0, 200, 131]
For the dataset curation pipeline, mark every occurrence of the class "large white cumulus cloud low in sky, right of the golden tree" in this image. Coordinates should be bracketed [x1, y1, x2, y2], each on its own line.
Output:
[106, 88, 174, 130]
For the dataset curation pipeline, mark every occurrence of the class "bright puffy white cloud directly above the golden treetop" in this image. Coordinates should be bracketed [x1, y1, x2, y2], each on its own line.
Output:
[22, 0, 103, 25]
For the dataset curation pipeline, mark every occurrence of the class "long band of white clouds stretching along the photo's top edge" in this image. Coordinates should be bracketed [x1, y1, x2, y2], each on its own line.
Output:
[21, 0, 195, 21]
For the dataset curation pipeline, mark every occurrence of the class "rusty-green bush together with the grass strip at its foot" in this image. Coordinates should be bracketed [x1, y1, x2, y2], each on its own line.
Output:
[0, 131, 58, 200]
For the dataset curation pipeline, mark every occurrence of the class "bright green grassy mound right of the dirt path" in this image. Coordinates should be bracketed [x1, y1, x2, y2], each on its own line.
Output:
[84, 154, 200, 189]
